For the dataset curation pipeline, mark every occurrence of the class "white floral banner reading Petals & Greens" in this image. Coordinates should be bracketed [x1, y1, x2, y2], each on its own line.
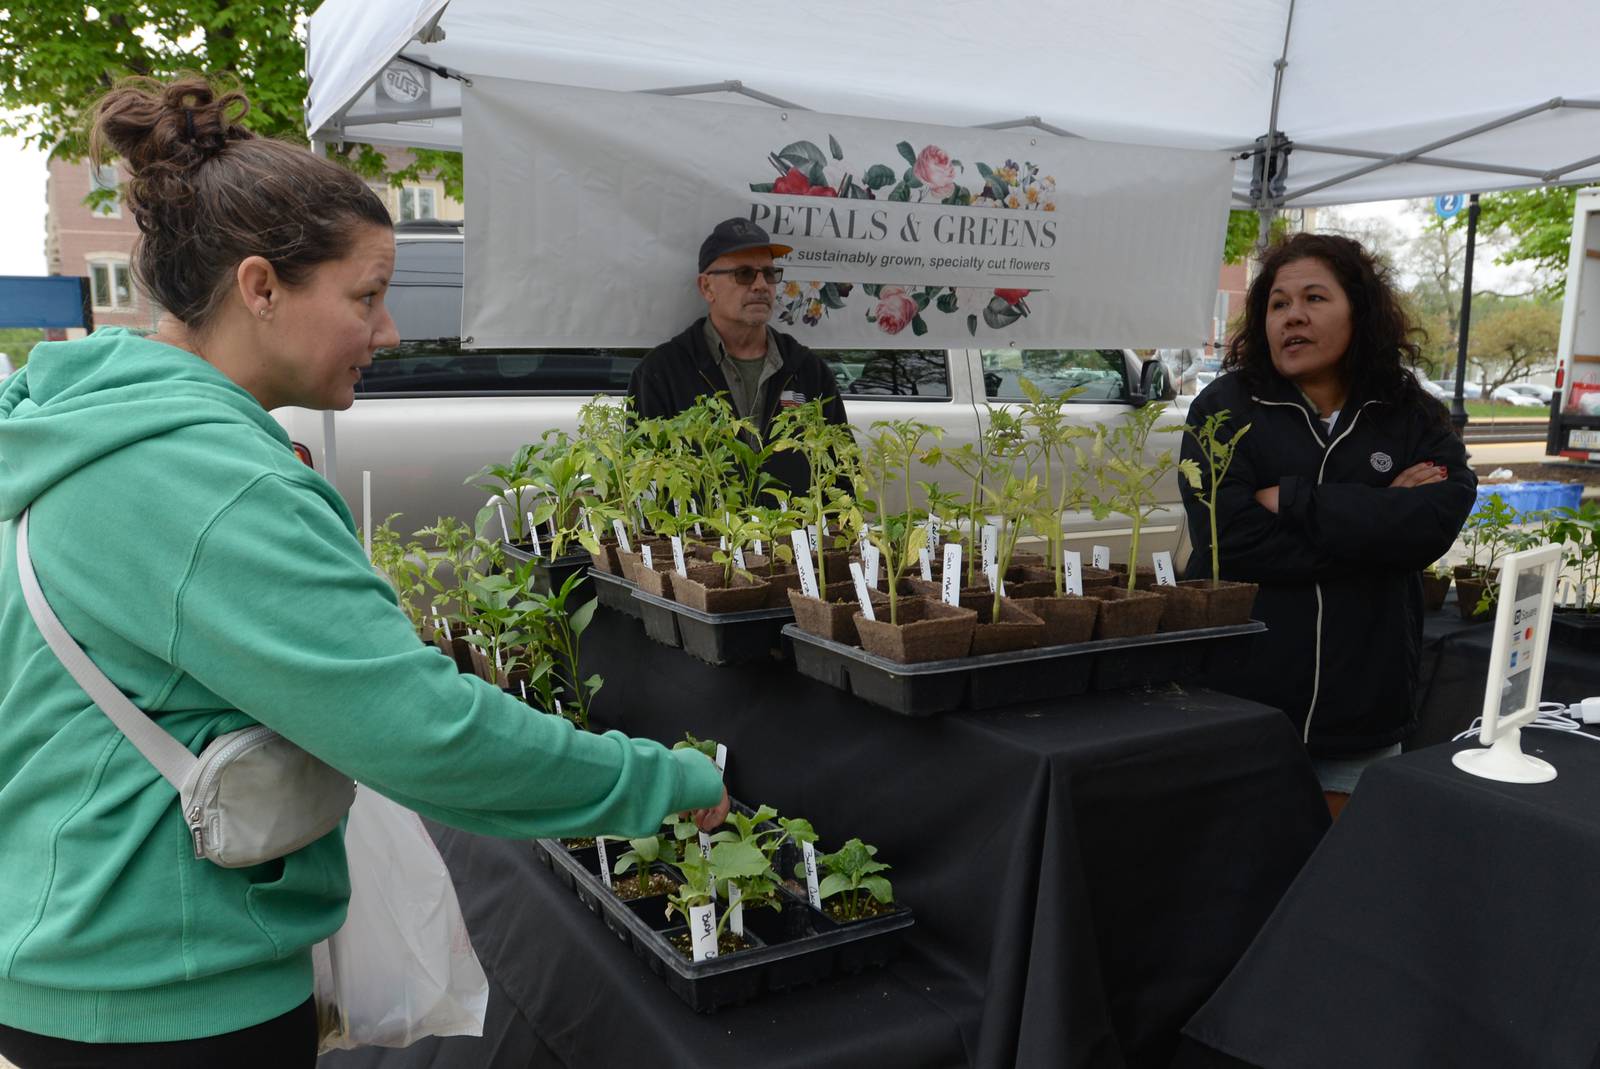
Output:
[462, 77, 1232, 349]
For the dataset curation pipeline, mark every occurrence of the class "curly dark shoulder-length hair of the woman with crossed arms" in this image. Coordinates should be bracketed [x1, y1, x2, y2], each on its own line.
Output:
[1222, 234, 1445, 418]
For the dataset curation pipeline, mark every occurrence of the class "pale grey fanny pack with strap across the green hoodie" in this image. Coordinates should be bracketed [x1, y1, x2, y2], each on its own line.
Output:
[16, 510, 355, 869]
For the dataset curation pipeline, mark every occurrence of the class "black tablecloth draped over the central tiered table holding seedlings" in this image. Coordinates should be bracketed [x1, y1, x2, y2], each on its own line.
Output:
[326, 611, 1326, 1069]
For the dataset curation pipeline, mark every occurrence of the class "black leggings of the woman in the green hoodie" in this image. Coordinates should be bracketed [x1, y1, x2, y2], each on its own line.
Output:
[0, 999, 317, 1069]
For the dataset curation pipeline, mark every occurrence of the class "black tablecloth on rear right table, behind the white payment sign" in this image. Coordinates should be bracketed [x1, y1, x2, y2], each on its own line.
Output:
[1406, 602, 1600, 749]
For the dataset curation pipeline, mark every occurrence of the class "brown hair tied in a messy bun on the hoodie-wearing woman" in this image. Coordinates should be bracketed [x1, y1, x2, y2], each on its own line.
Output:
[90, 75, 394, 330]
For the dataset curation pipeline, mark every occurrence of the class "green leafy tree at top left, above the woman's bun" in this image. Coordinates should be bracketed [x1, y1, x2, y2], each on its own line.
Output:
[0, 0, 462, 200]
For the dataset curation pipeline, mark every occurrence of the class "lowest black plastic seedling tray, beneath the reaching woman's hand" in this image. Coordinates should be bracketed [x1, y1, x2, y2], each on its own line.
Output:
[534, 839, 915, 1013]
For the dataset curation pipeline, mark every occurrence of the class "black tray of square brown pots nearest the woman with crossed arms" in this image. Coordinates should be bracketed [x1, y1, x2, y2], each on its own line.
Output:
[782, 621, 1267, 717]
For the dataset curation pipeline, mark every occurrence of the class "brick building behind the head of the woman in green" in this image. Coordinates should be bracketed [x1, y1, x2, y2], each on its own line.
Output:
[45, 149, 462, 328]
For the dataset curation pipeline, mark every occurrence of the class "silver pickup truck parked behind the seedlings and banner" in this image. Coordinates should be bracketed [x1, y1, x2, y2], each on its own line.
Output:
[274, 224, 1187, 559]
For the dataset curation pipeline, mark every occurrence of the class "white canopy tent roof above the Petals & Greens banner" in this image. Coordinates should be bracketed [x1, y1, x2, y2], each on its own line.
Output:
[306, 0, 1600, 210]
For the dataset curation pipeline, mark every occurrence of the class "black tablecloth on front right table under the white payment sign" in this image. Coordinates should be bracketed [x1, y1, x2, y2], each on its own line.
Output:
[1179, 731, 1600, 1069]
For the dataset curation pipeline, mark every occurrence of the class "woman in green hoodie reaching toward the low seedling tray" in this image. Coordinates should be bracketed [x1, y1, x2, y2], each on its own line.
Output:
[0, 80, 728, 1069]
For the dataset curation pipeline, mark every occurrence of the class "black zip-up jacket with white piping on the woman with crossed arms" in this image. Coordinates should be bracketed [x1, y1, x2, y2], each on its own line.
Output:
[1179, 374, 1478, 755]
